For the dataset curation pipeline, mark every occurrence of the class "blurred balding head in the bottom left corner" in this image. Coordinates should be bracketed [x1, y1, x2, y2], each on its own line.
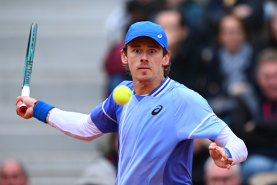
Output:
[0, 160, 28, 185]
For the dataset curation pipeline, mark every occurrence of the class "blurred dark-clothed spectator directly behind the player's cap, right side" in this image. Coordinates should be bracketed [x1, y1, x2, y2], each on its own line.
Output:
[155, 8, 199, 90]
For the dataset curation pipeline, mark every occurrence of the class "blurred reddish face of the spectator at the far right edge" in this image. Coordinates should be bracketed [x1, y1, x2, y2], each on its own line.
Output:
[257, 61, 277, 101]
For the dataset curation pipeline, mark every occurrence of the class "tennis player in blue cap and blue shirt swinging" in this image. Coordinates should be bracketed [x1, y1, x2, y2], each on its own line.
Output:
[16, 21, 248, 185]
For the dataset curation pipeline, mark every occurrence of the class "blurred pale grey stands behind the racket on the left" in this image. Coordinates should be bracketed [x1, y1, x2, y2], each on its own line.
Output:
[0, 0, 123, 185]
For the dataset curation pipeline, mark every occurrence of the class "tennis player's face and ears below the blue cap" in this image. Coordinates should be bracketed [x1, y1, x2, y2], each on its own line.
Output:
[121, 37, 169, 82]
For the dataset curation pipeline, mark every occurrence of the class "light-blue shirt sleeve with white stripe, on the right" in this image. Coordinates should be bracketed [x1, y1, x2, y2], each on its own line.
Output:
[173, 88, 226, 141]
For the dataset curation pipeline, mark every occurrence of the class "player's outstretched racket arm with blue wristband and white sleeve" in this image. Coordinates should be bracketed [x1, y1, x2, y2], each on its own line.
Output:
[16, 96, 103, 141]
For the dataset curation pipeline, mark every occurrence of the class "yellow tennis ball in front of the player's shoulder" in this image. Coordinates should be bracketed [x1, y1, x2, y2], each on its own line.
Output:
[113, 85, 132, 105]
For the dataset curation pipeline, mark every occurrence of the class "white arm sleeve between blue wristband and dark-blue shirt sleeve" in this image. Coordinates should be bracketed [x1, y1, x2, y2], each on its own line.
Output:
[48, 108, 104, 141]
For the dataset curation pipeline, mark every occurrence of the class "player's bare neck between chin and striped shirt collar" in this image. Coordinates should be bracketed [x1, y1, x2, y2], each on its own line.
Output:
[133, 77, 165, 95]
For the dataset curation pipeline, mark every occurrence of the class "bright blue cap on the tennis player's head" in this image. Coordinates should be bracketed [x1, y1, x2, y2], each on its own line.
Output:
[125, 21, 167, 49]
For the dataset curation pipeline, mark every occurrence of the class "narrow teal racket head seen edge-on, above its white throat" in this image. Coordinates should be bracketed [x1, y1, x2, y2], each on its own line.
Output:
[22, 23, 37, 87]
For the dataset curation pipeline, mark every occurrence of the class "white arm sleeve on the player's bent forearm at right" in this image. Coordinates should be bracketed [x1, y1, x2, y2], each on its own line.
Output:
[215, 126, 248, 165]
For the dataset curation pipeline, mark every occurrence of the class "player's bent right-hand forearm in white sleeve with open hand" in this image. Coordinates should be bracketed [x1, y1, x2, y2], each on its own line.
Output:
[209, 126, 248, 168]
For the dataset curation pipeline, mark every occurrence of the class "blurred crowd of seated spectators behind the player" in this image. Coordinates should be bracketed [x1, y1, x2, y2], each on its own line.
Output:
[104, 0, 277, 185]
